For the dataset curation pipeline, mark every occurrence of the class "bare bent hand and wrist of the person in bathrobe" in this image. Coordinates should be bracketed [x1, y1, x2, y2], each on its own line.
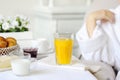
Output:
[86, 10, 115, 37]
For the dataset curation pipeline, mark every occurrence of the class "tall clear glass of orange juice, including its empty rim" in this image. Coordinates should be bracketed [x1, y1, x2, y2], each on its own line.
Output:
[54, 33, 73, 65]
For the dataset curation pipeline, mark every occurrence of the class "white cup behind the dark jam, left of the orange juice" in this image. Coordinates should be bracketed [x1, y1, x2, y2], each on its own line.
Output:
[36, 38, 50, 54]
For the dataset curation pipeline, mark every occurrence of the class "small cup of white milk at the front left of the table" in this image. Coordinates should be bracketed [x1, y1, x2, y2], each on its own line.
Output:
[11, 59, 30, 76]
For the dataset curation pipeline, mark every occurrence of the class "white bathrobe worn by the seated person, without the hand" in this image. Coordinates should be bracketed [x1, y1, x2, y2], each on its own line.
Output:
[76, 6, 120, 80]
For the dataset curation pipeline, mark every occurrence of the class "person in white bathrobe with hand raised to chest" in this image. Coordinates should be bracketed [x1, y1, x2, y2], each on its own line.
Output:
[76, 3, 120, 80]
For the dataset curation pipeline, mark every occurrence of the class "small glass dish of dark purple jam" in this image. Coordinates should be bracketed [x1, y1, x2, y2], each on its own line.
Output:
[23, 48, 38, 58]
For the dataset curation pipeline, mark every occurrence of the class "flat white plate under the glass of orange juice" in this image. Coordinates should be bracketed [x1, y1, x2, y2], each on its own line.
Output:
[38, 54, 86, 70]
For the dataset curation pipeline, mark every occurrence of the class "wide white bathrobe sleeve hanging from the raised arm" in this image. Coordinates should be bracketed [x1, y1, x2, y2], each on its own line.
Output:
[76, 24, 114, 66]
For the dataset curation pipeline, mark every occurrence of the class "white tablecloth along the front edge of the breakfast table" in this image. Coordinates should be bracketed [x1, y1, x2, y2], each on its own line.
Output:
[0, 63, 97, 80]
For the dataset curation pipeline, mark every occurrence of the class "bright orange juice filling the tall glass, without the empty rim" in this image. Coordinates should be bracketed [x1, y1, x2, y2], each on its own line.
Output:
[54, 38, 73, 64]
